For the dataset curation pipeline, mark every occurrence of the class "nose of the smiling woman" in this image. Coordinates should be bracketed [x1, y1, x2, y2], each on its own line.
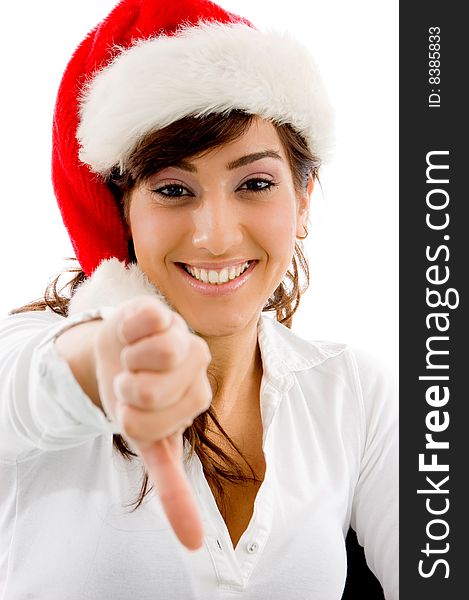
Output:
[192, 193, 243, 255]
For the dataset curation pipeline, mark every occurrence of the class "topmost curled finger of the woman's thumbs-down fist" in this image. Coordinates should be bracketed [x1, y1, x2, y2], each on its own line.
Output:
[117, 297, 173, 344]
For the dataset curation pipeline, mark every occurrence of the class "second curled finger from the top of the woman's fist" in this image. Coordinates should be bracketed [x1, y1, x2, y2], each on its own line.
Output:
[121, 324, 191, 371]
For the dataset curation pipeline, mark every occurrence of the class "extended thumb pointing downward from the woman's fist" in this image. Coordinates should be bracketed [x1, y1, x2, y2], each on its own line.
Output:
[140, 439, 204, 550]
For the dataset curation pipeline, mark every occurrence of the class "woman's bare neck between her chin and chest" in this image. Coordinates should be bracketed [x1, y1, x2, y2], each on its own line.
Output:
[199, 322, 262, 422]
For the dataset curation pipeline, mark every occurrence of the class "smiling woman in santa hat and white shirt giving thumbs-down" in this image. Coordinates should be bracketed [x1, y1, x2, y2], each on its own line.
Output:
[0, 0, 397, 599]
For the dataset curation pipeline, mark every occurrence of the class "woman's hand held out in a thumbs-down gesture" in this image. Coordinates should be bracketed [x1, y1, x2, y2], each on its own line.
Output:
[95, 296, 212, 550]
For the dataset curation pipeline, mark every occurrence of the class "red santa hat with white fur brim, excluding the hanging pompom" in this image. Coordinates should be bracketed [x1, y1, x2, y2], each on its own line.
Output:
[52, 0, 332, 275]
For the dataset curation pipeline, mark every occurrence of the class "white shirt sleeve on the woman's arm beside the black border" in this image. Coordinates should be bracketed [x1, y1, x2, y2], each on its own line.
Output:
[351, 350, 399, 600]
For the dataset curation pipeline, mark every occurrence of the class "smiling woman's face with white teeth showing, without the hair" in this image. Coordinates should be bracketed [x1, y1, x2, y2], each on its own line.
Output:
[129, 118, 312, 336]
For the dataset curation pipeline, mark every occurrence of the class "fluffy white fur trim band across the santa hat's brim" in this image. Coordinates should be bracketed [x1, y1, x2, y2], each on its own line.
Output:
[77, 23, 333, 176]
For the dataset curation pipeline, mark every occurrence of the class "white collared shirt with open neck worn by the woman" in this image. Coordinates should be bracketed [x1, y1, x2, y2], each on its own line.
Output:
[0, 311, 398, 600]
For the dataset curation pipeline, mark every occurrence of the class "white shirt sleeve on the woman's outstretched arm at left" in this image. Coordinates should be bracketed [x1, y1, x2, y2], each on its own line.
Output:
[0, 308, 118, 462]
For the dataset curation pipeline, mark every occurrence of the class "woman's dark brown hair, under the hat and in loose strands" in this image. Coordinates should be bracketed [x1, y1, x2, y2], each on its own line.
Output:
[11, 111, 320, 516]
